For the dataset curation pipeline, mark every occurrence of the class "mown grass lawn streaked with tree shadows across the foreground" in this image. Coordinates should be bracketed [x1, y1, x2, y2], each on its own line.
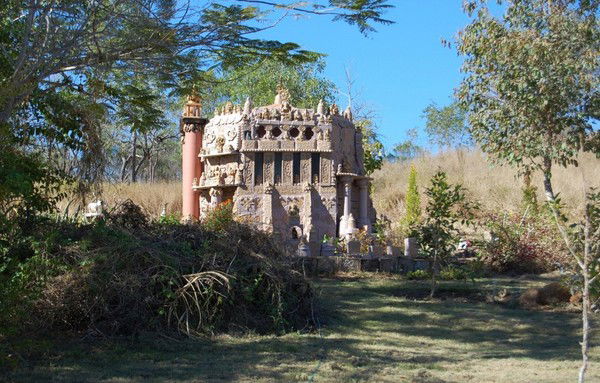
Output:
[0, 278, 600, 383]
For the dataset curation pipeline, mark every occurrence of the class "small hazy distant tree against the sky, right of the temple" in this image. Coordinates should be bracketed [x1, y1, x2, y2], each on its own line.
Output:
[422, 101, 471, 149]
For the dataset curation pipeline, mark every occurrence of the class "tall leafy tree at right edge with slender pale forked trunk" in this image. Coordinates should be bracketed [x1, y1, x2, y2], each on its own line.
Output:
[458, 0, 600, 382]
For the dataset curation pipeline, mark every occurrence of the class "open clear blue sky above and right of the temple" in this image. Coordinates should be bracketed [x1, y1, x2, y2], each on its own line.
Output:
[261, 0, 478, 149]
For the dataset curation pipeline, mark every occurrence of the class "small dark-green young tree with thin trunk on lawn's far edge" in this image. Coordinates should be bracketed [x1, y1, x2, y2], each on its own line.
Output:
[418, 170, 477, 298]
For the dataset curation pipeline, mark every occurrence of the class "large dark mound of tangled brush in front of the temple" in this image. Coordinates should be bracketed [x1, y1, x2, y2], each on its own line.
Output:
[3, 202, 313, 336]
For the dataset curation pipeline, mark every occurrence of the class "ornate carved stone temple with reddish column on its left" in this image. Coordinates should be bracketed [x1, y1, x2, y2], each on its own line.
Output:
[181, 87, 375, 255]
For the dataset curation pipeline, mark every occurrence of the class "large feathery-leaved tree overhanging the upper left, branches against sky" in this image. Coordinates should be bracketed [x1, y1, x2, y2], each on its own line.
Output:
[0, 0, 391, 207]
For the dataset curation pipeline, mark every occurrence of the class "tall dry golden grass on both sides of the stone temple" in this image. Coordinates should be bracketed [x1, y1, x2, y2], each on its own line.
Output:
[77, 150, 600, 221]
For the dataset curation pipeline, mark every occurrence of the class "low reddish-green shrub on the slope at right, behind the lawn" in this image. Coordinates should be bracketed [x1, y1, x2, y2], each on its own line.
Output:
[479, 214, 571, 273]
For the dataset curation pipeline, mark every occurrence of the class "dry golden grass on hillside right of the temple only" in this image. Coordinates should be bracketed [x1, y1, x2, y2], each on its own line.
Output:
[373, 150, 600, 228]
